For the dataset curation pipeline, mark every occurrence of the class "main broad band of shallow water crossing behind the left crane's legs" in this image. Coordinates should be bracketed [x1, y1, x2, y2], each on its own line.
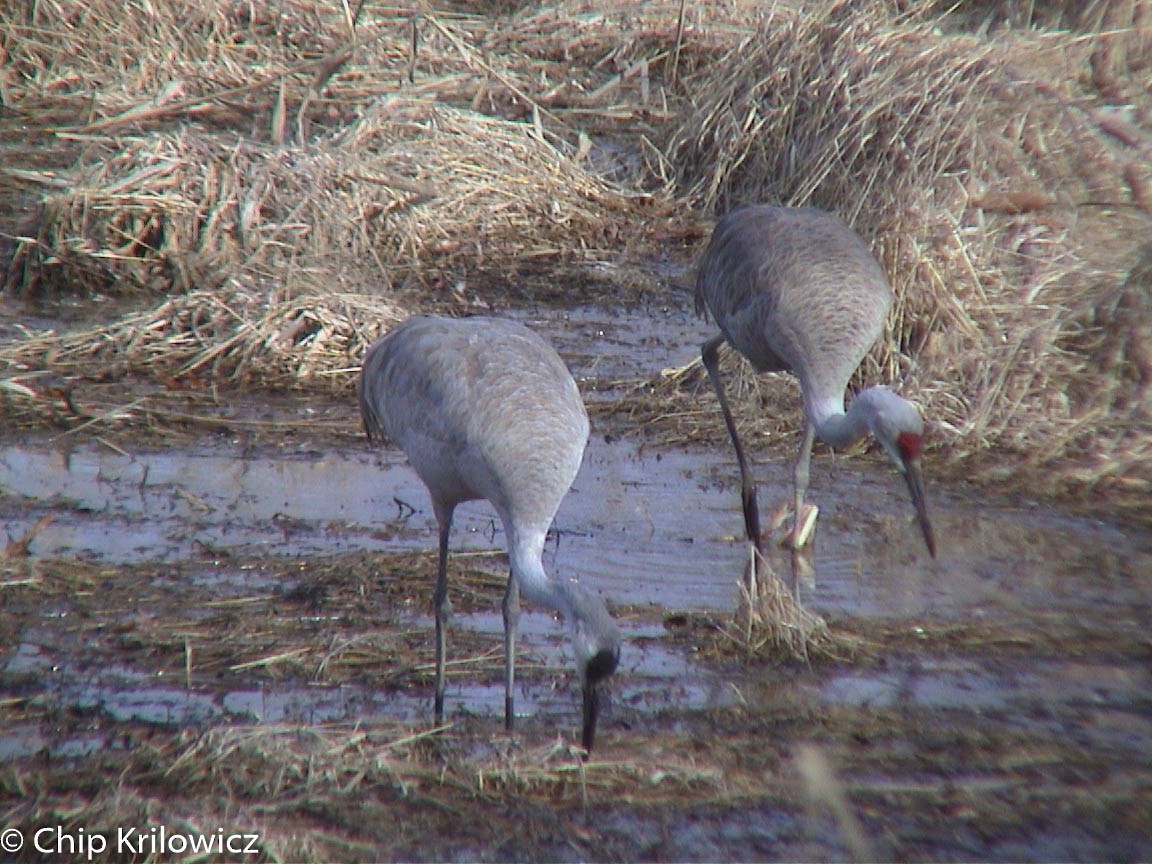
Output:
[0, 421, 1152, 715]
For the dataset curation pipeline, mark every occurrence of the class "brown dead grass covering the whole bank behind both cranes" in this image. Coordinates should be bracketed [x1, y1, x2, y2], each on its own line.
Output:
[0, 0, 1152, 508]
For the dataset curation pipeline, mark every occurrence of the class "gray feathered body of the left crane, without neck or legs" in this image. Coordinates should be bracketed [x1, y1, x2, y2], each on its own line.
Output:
[359, 316, 589, 522]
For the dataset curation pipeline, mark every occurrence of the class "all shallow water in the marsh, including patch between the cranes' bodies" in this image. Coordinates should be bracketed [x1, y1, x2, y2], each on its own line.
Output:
[0, 310, 1152, 857]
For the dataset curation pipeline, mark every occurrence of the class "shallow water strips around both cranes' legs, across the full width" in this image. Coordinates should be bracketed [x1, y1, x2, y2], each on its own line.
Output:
[0, 419, 1152, 737]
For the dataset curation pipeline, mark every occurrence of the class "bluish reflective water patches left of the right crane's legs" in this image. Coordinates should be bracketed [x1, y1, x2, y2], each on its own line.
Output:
[0, 437, 743, 750]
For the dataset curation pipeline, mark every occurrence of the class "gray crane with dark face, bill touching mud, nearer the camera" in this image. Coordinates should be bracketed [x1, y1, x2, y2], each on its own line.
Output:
[357, 316, 621, 750]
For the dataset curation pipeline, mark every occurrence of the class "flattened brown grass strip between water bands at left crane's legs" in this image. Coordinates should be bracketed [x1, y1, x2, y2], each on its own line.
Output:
[0, 555, 518, 689]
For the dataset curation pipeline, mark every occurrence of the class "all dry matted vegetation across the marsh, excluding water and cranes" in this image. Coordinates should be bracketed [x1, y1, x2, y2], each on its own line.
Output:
[0, 0, 1152, 861]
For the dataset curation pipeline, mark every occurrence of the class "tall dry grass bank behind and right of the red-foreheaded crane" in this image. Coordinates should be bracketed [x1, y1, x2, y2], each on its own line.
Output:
[646, 3, 1152, 507]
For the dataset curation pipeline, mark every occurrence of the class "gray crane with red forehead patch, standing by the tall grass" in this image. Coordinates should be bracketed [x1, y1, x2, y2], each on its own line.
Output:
[696, 205, 935, 571]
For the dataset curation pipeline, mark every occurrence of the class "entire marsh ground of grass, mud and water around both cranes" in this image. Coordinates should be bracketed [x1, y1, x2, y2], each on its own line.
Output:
[0, 0, 1152, 862]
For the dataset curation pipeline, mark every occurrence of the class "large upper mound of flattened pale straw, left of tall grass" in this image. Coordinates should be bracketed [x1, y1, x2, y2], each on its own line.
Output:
[9, 97, 668, 295]
